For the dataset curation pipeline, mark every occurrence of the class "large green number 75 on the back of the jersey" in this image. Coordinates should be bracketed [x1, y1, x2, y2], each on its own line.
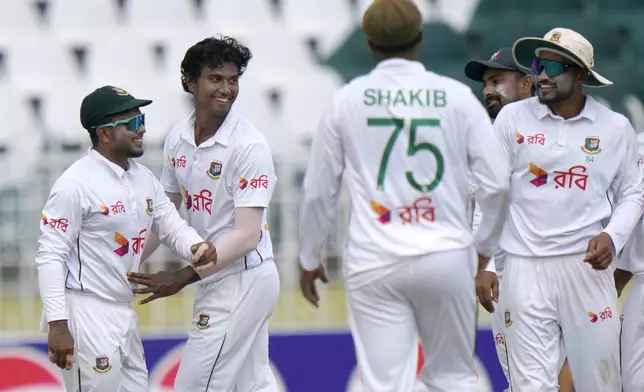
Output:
[367, 118, 445, 192]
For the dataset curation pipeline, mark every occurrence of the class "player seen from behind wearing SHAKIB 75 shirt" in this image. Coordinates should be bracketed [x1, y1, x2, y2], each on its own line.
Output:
[299, 0, 509, 392]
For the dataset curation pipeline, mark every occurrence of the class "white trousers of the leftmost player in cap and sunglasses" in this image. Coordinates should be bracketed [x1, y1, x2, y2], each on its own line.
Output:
[63, 290, 148, 392]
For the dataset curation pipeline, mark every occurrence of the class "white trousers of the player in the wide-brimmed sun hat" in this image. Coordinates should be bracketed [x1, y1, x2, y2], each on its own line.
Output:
[500, 253, 622, 392]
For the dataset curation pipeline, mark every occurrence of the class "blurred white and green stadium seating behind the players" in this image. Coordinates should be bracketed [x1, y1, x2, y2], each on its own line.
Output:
[0, 0, 644, 334]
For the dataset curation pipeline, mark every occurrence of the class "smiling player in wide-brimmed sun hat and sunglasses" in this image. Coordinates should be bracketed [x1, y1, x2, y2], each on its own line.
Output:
[494, 28, 644, 392]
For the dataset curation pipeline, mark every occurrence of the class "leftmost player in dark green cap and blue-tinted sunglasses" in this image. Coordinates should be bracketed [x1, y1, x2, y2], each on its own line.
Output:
[36, 86, 215, 392]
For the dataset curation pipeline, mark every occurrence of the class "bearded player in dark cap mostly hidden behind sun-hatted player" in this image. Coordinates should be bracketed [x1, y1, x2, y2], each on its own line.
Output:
[465, 48, 573, 392]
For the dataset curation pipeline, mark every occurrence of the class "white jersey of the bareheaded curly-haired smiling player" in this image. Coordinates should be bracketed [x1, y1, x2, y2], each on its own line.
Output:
[161, 110, 277, 284]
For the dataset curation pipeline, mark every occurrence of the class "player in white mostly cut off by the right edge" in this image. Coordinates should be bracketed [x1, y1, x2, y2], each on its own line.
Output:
[614, 133, 644, 392]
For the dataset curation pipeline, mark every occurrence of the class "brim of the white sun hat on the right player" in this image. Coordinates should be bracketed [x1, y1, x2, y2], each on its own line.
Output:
[512, 37, 613, 87]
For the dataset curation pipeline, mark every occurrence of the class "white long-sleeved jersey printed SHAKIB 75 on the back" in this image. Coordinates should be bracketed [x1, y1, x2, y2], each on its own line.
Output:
[299, 59, 509, 287]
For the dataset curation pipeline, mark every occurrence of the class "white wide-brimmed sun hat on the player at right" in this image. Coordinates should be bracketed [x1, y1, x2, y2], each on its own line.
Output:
[512, 27, 613, 87]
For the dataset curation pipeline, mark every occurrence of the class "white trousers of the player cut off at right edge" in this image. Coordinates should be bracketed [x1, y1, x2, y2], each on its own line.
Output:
[621, 275, 644, 392]
